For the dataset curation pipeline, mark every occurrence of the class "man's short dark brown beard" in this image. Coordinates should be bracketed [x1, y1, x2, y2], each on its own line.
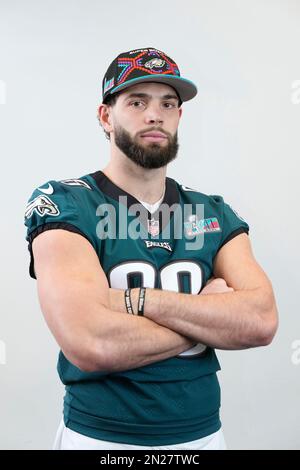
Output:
[115, 125, 179, 170]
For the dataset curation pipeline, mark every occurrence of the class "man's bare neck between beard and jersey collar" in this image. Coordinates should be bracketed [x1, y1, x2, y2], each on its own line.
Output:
[102, 154, 167, 204]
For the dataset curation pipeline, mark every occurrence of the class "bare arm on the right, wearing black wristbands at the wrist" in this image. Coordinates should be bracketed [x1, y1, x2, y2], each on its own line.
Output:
[110, 234, 278, 349]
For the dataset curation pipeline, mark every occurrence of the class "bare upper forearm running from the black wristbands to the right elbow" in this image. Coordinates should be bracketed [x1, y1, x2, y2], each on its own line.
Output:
[144, 289, 276, 349]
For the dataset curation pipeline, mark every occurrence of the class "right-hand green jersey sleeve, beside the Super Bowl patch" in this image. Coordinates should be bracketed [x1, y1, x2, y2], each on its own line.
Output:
[211, 195, 249, 251]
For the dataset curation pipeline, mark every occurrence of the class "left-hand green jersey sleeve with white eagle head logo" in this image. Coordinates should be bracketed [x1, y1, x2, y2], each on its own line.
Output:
[24, 181, 96, 279]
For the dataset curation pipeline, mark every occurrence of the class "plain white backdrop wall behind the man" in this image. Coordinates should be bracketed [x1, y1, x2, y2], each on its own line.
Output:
[0, 0, 300, 449]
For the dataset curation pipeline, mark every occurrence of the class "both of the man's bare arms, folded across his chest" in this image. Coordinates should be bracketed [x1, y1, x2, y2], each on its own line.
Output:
[33, 229, 277, 371]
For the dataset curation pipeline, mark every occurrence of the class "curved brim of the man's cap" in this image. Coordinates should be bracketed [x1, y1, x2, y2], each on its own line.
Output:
[104, 74, 198, 101]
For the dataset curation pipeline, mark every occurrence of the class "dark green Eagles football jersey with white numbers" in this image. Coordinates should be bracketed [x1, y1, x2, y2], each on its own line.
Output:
[25, 171, 249, 446]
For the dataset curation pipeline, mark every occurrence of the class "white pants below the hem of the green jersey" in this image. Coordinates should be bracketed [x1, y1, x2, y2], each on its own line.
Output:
[53, 419, 227, 450]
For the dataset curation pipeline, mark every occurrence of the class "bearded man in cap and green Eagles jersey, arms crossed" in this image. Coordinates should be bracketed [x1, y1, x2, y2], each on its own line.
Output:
[25, 48, 277, 449]
